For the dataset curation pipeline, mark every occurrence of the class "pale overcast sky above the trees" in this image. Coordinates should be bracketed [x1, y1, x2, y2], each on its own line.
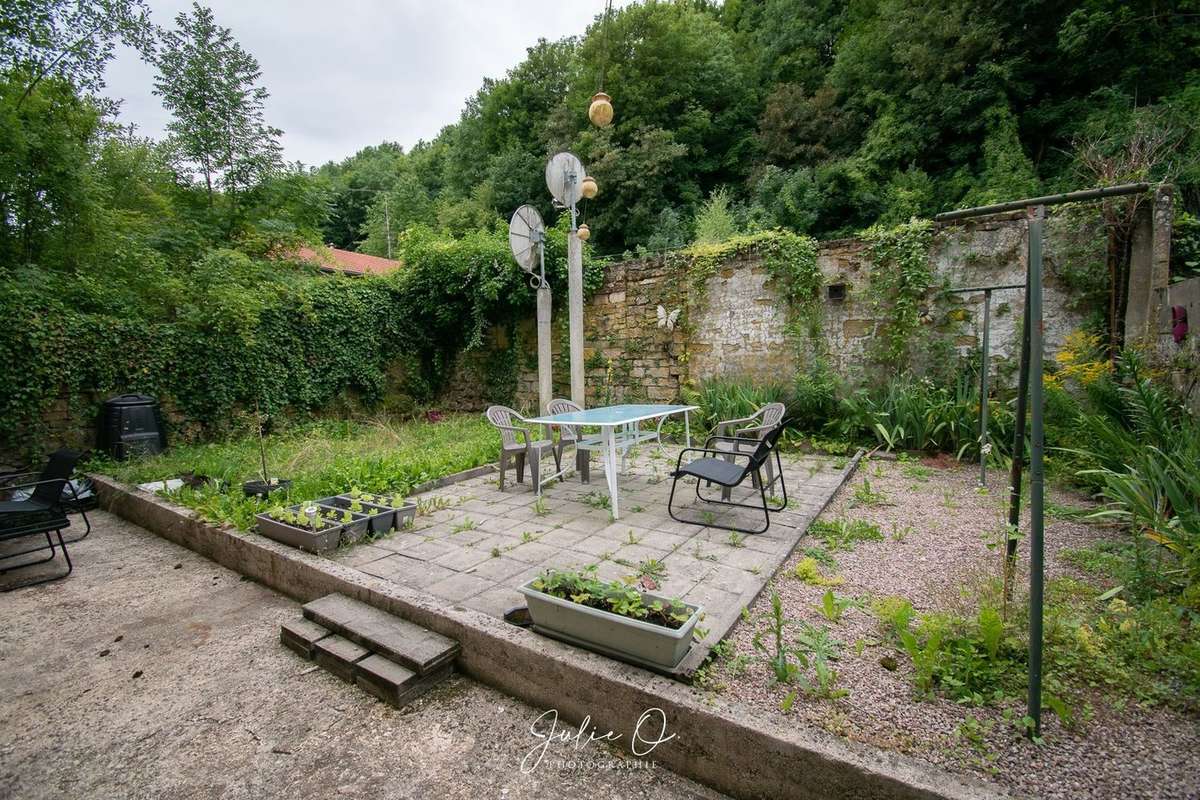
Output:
[106, 0, 628, 166]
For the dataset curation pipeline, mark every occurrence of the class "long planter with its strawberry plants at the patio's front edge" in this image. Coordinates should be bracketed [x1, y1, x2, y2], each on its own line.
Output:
[518, 567, 703, 669]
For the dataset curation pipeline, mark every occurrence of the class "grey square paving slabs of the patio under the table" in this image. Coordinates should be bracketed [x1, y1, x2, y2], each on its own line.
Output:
[332, 446, 852, 670]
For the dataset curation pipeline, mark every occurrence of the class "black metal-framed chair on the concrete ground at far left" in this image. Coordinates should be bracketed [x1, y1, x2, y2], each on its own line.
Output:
[0, 449, 91, 591]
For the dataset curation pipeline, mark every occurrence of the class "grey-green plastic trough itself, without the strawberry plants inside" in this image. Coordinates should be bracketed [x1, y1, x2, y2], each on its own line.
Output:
[517, 578, 703, 669]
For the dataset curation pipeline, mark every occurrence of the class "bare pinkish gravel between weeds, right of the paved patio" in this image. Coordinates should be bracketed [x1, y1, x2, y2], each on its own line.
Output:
[709, 461, 1200, 799]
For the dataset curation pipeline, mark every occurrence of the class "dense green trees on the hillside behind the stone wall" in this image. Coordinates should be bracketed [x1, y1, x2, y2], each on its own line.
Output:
[320, 0, 1200, 252]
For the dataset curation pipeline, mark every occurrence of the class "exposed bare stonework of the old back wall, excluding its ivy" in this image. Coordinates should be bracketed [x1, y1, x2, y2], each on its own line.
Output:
[492, 209, 1104, 411]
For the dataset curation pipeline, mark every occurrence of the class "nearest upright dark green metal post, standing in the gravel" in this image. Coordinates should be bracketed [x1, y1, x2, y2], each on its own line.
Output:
[1026, 205, 1046, 736]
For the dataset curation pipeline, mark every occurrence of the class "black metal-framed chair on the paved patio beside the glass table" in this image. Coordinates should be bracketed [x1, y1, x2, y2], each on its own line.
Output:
[667, 422, 787, 534]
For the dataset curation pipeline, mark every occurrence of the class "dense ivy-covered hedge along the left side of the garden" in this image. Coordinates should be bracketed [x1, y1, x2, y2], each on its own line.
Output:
[0, 219, 604, 455]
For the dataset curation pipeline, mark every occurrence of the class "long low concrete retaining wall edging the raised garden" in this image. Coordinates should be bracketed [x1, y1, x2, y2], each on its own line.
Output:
[94, 476, 1000, 800]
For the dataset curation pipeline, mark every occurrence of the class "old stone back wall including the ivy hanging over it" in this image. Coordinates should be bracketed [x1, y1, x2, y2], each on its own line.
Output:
[492, 212, 1106, 411]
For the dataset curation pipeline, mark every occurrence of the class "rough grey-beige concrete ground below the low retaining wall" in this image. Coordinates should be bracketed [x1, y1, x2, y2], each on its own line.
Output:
[0, 512, 721, 800]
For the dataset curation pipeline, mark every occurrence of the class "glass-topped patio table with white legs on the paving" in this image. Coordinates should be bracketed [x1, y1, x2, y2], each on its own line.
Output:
[526, 403, 700, 519]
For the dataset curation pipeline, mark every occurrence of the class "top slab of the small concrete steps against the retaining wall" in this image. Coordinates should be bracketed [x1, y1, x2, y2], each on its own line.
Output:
[302, 595, 460, 678]
